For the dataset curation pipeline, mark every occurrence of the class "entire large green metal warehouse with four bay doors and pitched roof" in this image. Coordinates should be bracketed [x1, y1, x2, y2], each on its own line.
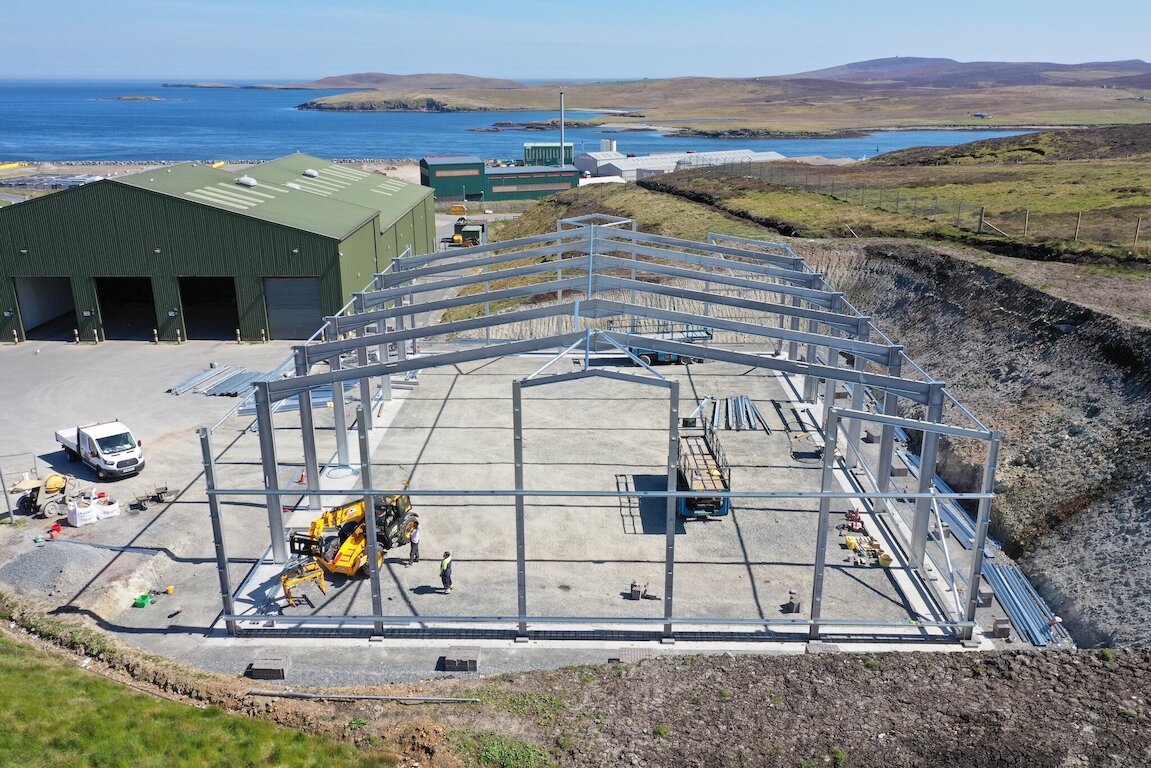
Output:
[0, 154, 435, 341]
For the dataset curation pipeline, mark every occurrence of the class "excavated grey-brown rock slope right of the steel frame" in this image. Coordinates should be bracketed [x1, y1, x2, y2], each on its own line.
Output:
[800, 243, 1151, 645]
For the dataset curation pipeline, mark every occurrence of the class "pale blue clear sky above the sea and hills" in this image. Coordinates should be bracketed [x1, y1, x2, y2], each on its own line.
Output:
[0, 0, 1151, 81]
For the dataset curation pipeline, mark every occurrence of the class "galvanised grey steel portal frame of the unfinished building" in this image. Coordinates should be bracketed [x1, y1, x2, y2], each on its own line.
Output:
[200, 215, 1003, 639]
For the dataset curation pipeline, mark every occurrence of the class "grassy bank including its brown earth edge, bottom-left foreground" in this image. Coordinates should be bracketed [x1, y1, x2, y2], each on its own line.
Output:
[0, 591, 559, 768]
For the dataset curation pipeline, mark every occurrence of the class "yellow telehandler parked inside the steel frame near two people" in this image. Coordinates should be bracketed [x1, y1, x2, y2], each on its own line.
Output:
[280, 481, 419, 606]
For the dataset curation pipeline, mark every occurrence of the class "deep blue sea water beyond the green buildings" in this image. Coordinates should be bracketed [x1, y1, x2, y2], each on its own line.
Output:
[0, 81, 1020, 162]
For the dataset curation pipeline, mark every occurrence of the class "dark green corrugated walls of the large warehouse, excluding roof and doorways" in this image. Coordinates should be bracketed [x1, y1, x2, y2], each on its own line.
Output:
[0, 181, 435, 341]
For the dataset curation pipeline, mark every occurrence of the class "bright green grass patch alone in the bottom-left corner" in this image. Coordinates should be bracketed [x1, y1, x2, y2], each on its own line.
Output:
[0, 637, 392, 768]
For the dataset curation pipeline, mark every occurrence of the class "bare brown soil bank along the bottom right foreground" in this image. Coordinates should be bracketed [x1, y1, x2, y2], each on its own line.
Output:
[517, 652, 1151, 768]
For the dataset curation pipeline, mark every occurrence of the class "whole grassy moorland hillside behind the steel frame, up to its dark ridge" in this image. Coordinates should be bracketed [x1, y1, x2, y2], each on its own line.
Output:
[444, 129, 1151, 331]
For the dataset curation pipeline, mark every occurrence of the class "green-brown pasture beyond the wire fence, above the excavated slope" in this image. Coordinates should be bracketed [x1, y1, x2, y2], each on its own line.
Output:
[641, 160, 1151, 260]
